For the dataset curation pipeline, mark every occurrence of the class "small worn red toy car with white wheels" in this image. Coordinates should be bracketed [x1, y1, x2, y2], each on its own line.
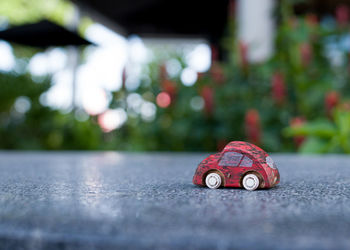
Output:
[193, 141, 280, 191]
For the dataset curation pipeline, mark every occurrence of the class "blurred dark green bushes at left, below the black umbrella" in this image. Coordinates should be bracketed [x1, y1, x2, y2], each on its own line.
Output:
[0, 71, 102, 149]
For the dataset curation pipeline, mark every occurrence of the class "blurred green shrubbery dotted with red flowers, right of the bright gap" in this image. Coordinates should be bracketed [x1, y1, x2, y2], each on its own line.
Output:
[114, 1, 350, 153]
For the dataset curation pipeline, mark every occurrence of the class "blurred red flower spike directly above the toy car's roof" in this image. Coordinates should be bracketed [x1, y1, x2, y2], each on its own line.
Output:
[244, 109, 261, 145]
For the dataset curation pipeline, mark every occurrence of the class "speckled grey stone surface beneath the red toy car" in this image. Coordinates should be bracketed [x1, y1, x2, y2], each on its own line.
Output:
[0, 152, 350, 250]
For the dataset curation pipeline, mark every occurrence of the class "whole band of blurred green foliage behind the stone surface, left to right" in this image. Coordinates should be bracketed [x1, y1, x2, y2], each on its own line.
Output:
[0, 0, 350, 153]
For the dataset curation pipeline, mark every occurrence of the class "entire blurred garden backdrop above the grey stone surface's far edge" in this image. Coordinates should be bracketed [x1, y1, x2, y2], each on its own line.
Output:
[0, 0, 350, 153]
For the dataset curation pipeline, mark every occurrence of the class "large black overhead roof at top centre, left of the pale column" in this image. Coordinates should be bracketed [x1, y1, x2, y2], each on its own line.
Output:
[72, 0, 233, 58]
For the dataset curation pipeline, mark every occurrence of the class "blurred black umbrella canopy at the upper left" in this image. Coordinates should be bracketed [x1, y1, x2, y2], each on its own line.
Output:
[0, 20, 92, 48]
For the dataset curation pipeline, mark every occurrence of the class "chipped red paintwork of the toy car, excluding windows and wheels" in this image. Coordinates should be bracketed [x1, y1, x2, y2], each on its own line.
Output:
[193, 141, 280, 188]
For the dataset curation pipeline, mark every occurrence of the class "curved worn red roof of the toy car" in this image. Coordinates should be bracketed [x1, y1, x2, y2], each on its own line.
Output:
[222, 141, 267, 162]
